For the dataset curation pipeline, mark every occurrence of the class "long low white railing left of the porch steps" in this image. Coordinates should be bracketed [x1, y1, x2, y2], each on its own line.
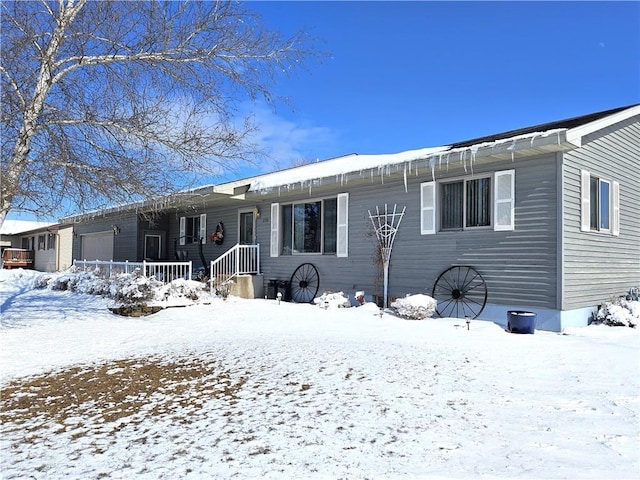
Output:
[73, 260, 193, 283]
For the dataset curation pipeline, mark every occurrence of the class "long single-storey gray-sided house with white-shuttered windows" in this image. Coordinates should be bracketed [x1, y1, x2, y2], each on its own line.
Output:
[65, 105, 640, 331]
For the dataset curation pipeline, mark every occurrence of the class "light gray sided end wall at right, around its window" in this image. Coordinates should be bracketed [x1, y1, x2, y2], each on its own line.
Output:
[558, 114, 640, 311]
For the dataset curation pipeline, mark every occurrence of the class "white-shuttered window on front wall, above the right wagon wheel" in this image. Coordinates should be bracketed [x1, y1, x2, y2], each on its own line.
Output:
[420, 170, 515, 235]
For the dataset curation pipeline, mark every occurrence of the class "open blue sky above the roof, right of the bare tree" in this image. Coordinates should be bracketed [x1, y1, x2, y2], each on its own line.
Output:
[8, 1, 640, 219]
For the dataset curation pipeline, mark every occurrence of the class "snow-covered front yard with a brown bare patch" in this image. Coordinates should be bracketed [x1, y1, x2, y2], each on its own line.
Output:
[0, 270, 640, 479]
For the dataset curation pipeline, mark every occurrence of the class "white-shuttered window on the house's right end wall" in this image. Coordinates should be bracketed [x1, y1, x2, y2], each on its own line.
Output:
[580, 170, 620, 235]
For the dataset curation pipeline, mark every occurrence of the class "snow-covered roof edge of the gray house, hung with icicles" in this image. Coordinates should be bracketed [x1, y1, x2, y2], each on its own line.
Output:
[61, 104, 640, 220]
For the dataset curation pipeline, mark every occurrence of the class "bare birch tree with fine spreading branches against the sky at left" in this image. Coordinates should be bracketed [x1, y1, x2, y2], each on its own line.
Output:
[0, 0, 315, 224]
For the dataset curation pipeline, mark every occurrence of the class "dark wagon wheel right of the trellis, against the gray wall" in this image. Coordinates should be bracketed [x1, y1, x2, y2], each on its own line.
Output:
[431, 267, 487, 318]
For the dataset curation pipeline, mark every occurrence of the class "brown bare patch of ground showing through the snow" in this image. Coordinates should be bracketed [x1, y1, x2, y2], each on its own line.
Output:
[0, 352, 246, 435]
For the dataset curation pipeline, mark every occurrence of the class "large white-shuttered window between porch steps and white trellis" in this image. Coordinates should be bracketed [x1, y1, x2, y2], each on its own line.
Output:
[271, 193, 349, 257]
